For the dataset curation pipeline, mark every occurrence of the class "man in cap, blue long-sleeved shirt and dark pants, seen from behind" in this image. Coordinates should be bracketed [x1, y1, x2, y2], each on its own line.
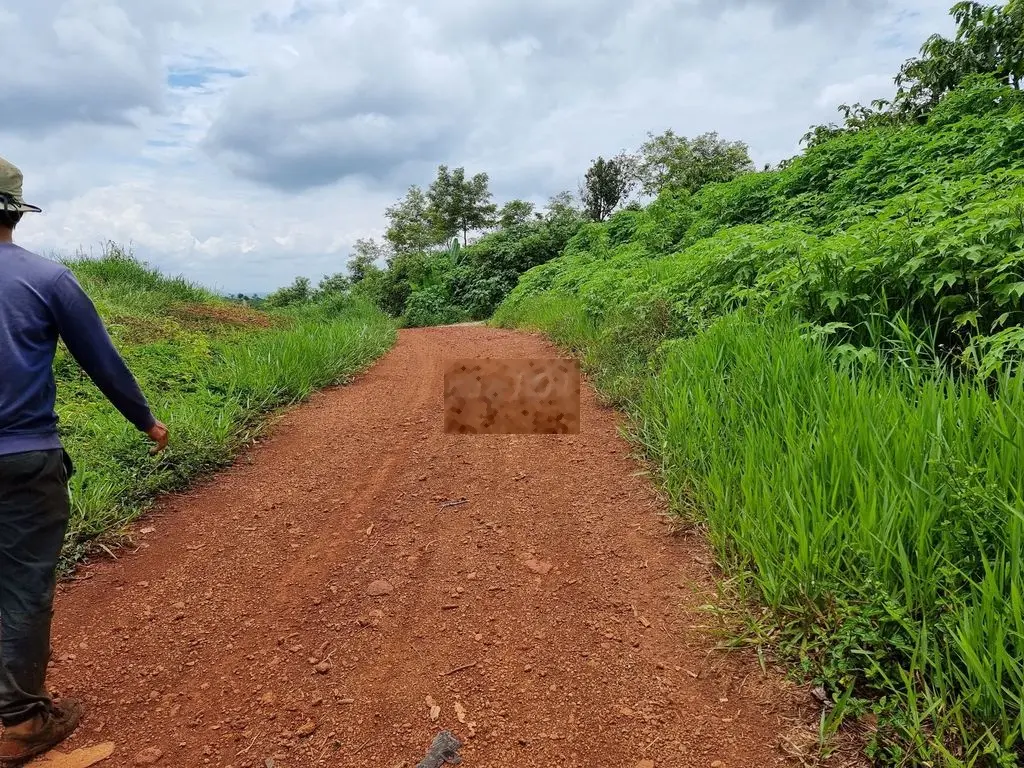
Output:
[0, 158, 167, 766]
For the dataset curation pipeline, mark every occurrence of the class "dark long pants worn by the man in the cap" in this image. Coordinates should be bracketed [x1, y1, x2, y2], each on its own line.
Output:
[0, 450, 74, 726]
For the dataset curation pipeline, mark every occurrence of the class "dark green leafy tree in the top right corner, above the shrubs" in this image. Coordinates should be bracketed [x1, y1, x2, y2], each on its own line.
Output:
[895, 0, 1024, 118]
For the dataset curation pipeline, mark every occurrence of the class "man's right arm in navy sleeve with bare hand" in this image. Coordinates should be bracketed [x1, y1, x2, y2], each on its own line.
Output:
[50, 270, 167, 449]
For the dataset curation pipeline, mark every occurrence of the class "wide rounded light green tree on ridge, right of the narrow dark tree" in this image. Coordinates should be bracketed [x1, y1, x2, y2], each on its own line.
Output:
[635, 129, 754, 195]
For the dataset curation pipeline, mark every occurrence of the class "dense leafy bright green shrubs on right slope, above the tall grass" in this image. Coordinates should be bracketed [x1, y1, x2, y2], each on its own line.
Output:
[509, 78, 1024, 373]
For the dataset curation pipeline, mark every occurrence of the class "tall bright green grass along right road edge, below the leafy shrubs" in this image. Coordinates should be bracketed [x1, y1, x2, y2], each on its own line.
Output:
[493, 293, 1024, 766]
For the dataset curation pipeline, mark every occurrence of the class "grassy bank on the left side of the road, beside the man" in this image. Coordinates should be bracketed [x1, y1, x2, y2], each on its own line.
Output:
[54, 247, 395, 563]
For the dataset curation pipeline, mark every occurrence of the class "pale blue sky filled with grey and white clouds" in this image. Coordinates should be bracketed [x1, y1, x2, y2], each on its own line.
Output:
[0, 0, 951, 293]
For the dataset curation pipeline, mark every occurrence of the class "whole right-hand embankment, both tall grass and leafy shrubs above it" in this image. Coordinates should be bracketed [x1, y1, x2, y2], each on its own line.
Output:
[495, 75, 1024, 766]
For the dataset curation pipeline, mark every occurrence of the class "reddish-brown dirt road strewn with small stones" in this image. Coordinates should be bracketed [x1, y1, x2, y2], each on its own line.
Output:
[51, 327, 815, 768]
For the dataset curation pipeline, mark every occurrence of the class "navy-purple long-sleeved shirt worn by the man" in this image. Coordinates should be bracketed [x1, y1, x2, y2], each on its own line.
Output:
[0, 243, 156, 456]
